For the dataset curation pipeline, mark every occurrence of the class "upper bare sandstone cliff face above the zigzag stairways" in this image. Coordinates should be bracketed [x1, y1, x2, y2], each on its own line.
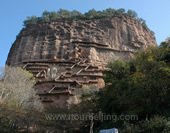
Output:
[6, 16, 156, 65]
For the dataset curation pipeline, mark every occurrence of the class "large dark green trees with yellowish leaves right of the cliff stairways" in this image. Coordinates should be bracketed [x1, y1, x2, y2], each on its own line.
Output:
[98, 41, 170, 128]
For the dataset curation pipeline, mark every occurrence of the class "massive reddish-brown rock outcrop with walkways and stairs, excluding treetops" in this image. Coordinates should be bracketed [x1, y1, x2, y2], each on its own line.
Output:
[6, 16, 156, 106]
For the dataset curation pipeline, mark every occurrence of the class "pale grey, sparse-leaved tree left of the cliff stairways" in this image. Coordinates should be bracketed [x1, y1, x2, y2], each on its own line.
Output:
[0, 67, 42, 110]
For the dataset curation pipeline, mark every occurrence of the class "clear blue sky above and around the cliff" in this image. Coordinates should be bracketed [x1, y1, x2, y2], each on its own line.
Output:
[0, 0, 170, 67]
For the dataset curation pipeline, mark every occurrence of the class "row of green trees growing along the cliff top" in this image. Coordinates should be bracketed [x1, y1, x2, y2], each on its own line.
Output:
[24, 8, 147, 27]
